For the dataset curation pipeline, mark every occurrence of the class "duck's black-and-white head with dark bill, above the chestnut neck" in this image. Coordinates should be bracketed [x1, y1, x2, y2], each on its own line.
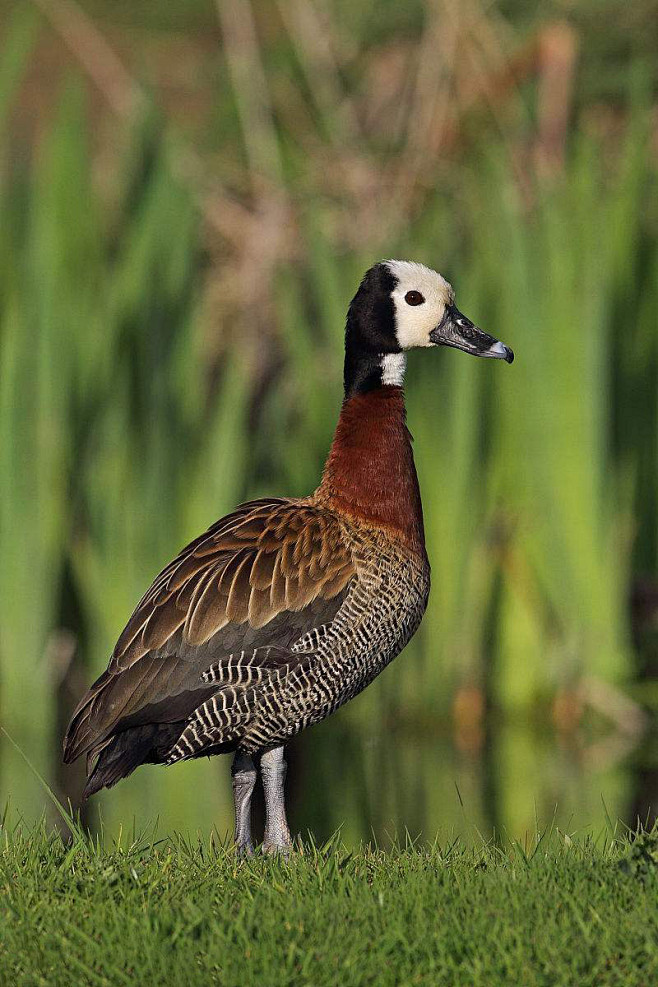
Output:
[345, 260, 514, 397]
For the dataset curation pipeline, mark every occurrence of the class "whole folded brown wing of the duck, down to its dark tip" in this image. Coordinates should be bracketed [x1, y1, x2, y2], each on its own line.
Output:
[65, 500, 355, 760]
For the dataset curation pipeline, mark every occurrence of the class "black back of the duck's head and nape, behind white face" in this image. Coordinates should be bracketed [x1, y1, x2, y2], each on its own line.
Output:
[343, 263, 402, 398]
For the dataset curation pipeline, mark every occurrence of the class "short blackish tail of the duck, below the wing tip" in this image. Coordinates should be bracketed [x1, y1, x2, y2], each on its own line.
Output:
[82, 721, 185, 799]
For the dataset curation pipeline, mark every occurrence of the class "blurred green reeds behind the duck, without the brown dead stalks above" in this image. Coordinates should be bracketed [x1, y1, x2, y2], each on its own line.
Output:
[0, 5, 658, 837]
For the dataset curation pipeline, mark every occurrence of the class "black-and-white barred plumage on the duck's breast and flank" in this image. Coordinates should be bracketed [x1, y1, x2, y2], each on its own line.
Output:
[167, 538, 429, 764]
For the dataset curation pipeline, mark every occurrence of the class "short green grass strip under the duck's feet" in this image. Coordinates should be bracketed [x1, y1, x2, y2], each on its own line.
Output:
[0, 826, 658, 987]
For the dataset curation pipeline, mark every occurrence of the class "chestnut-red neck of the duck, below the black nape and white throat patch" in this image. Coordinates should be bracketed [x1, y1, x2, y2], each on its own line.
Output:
[316, 384, 425, 555]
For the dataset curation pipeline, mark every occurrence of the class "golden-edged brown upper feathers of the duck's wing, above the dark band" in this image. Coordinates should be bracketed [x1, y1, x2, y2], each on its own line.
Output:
[111, 500, 354, 670]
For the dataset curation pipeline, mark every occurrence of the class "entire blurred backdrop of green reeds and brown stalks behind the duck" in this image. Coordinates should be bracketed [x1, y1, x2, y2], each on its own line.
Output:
[0, 0, 658, 840]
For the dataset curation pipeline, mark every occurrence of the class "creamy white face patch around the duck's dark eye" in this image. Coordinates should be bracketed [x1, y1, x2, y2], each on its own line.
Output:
[384, 260, 455, 350]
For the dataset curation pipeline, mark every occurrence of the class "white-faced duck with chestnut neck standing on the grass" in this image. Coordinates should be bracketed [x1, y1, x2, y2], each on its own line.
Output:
[64, 260, 514, 852]
